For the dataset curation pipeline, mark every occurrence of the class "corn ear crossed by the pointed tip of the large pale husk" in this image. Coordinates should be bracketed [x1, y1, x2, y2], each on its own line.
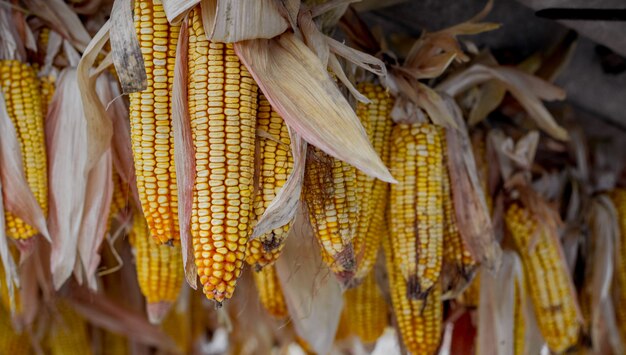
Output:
[353, 83, 394, 284]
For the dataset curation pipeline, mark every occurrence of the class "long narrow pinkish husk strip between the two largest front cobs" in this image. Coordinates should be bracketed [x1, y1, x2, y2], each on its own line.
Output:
[172, 18, 198, 290]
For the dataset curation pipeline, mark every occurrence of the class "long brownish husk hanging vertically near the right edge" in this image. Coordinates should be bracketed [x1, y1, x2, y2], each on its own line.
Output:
[587, 195, 624, 354]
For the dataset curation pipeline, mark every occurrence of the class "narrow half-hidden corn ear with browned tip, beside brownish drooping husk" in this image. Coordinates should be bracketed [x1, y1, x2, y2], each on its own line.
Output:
[439, 127, 477, 291]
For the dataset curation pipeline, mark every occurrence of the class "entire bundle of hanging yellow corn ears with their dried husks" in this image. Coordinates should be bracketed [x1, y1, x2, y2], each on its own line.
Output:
[0, 0, 626, 355]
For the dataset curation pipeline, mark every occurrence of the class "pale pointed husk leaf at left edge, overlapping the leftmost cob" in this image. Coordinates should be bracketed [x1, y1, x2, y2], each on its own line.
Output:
[0, 92, 50, 241]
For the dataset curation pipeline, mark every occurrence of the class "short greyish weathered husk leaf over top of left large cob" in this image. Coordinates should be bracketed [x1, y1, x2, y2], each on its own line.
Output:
[109, 0, 148, 94]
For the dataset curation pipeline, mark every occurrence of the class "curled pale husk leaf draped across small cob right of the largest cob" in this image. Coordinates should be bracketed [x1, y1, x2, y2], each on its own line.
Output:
[250, 128, 307, 239]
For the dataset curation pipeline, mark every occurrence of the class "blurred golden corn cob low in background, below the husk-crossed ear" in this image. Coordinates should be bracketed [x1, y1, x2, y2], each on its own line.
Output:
[342, 272, 388, 343]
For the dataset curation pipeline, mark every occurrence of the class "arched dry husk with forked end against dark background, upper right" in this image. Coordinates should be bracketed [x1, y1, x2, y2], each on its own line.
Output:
[437, 64, 568, 140]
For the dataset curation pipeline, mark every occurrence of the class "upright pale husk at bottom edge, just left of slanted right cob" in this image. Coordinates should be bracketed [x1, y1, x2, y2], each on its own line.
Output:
[476, 251, 526, 354]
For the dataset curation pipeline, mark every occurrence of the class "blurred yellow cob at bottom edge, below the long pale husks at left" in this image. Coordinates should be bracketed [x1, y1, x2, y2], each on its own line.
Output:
[48, 302, 93, 355]
